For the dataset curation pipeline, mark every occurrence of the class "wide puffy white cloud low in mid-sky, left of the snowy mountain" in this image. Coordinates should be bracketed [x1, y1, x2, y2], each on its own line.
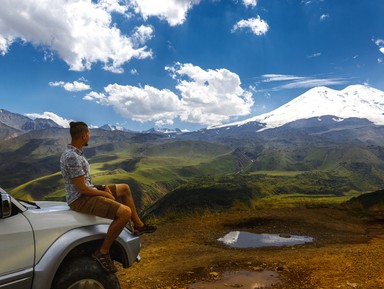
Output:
[84, 63, 253, 125]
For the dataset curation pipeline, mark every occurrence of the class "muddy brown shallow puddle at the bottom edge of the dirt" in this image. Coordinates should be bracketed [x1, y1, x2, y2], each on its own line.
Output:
[188, 270, 280, 289]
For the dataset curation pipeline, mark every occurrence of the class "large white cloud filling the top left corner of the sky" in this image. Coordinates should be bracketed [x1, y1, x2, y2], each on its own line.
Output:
[0, 0, 153, 72]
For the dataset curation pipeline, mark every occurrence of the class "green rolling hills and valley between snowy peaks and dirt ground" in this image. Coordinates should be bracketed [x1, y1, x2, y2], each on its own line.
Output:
[4, 124, 384, 214]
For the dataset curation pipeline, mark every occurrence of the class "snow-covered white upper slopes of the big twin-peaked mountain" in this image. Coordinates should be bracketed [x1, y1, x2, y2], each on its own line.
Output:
[220, 85, 384, 129]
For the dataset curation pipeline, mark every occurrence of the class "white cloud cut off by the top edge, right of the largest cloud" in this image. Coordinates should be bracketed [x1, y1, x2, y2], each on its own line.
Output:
[132, 0, 200, 26]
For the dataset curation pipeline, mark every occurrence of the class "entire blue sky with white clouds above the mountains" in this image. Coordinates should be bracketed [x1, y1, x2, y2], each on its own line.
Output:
[0, 0, 384, 131]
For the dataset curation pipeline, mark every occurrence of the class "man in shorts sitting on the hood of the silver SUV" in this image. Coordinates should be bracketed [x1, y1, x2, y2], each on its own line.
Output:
[60, 122, 156, 272]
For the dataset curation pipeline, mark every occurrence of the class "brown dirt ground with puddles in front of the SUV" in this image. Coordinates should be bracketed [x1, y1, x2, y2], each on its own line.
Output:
[118, 208, 384, 289]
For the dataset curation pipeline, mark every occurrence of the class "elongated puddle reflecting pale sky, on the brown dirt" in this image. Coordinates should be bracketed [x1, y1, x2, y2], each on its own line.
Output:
[218, 231, 313, 248]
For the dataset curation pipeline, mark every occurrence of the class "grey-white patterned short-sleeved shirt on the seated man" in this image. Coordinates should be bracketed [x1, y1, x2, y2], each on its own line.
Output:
[60, 145, 95, 205]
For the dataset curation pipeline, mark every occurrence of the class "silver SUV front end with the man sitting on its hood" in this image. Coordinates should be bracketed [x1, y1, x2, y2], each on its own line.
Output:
[0, 188, 141, 289]
